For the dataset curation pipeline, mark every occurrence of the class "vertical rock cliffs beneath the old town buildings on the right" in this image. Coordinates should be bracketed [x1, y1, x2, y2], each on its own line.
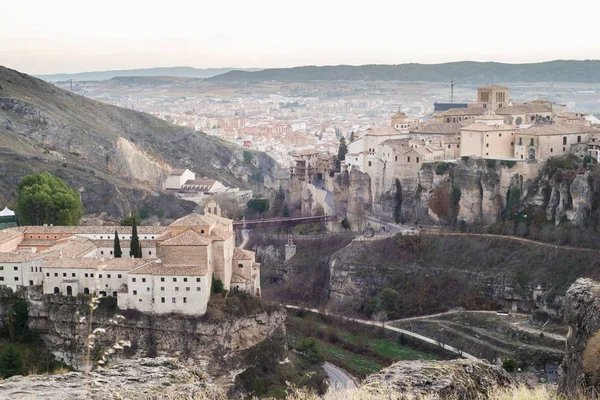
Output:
[334, 158, 600, 228]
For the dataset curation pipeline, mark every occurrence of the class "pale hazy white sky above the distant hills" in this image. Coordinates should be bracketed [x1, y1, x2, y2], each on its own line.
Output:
[0, 0, 600, 74]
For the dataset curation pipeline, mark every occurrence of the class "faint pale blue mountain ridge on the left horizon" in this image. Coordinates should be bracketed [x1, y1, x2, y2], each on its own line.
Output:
[34, 67, 260, 82]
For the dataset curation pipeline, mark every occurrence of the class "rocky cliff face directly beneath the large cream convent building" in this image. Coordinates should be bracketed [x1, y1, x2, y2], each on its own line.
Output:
[0, 289, 286, 383]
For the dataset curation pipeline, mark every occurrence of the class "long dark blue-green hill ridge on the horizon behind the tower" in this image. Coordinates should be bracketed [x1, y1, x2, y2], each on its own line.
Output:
[209, 60, 600, 84]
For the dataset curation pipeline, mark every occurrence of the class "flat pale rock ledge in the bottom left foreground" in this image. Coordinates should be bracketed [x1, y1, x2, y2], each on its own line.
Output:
[0, 357, 220, 400]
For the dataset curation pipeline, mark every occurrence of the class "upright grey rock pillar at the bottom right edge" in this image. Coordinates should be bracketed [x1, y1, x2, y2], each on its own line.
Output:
[559, 279, 600, 395]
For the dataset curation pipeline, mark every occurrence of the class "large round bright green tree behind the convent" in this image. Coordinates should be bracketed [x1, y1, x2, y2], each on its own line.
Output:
[16, 172, 83, 225]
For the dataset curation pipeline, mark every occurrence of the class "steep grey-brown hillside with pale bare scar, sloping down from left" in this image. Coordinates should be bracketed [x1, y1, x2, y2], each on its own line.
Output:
[0, 67, 278, 218]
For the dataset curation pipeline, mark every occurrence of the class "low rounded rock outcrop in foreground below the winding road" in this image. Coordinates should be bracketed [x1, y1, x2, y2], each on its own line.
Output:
[363, 360, 514, 400]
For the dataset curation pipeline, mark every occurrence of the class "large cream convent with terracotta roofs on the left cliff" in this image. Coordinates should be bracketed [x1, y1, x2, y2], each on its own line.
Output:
[0, 202, 261, 315]
